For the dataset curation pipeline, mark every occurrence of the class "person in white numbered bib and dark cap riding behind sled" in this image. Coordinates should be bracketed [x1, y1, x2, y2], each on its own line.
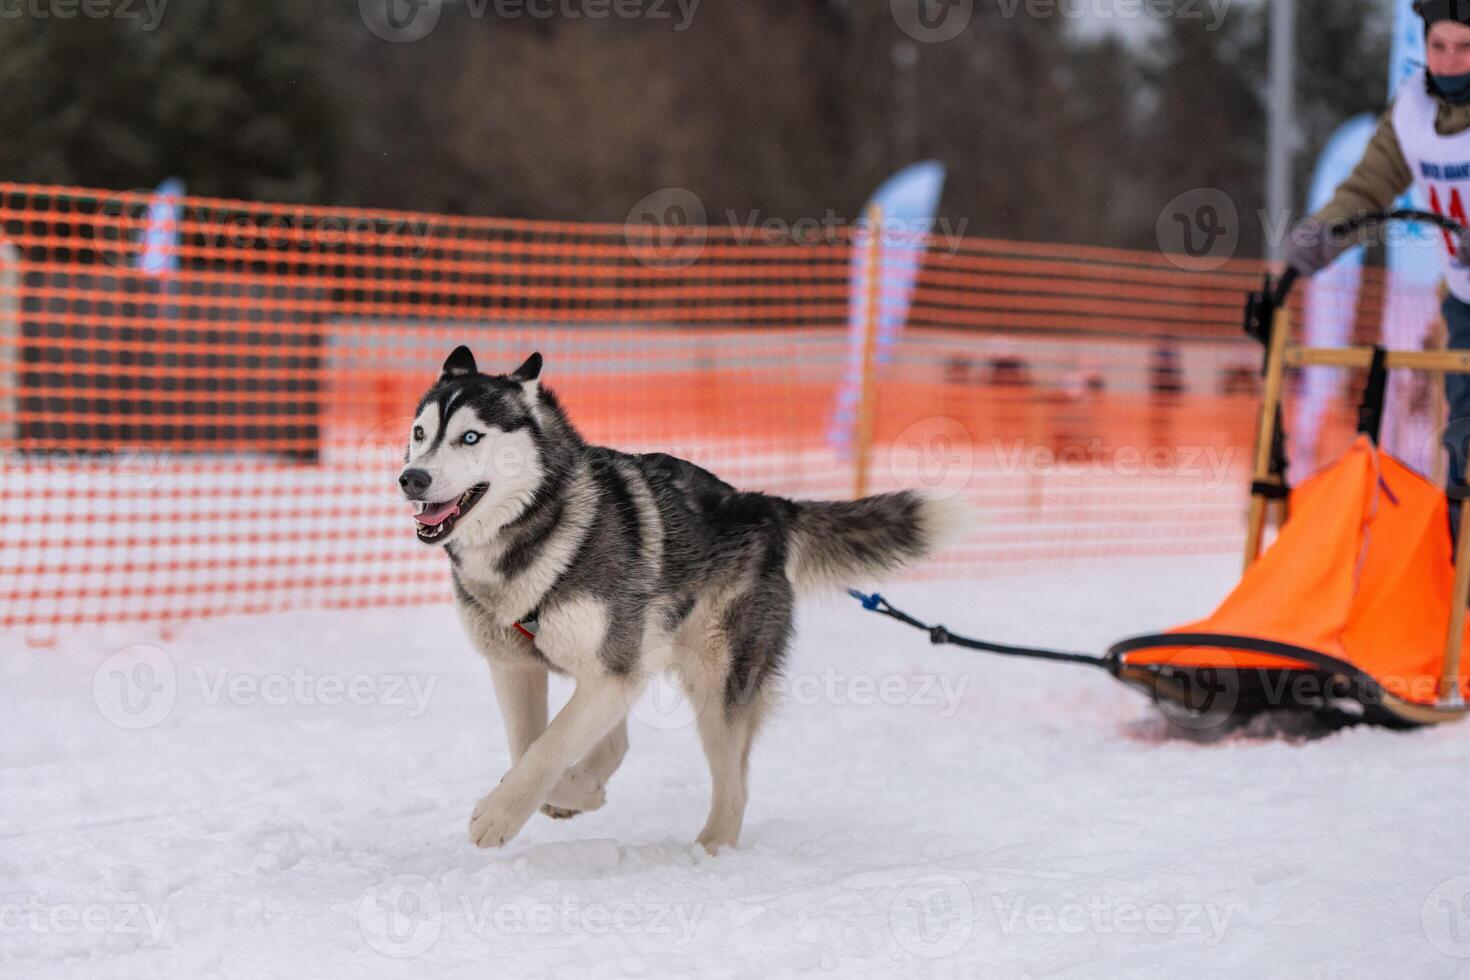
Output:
[1286, 0, 1470, 532]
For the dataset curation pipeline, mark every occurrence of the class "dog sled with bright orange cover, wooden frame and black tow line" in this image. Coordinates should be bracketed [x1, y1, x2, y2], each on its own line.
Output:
[853, 212, 1470, 730]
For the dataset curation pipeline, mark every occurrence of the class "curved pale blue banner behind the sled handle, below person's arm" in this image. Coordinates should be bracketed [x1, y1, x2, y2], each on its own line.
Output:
[1288, 113, 1377, 482]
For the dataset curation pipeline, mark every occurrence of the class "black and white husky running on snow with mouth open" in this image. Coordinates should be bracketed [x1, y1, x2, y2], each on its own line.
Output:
[398, 347, 954, 851]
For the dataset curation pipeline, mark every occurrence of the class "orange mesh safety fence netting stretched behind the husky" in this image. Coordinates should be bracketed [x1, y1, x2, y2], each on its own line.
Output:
[0, 184, 1446, 635]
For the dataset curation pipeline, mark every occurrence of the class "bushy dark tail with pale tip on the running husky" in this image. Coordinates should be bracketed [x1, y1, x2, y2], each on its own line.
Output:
[786, 491, 973, 595]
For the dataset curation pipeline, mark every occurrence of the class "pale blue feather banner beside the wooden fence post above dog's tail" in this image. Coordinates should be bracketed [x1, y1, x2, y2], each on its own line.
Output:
[828, 160, 945, 458]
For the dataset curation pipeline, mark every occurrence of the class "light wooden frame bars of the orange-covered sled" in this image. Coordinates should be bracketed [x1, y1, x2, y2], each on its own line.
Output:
[1245, 303, 1470, 724]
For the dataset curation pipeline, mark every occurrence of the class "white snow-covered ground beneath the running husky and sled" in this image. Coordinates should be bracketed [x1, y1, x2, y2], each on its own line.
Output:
[0, 558, 1470, 980]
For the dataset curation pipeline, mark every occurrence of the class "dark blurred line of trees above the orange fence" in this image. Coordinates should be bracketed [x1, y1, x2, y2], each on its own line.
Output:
[0, 0, 1388, 254]
